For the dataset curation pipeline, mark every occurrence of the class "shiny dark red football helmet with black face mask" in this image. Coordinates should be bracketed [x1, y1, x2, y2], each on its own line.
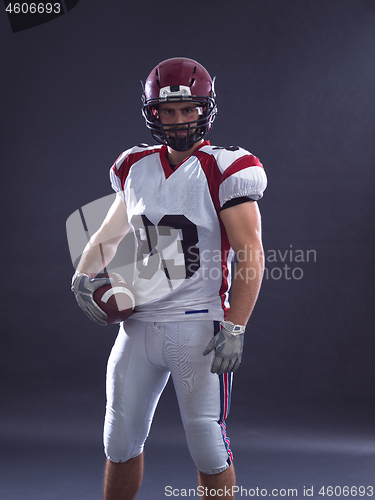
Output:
[142, 57, 217, 151]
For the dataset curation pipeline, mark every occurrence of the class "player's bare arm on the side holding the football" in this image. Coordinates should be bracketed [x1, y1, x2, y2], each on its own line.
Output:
[77, 194, 130, 277]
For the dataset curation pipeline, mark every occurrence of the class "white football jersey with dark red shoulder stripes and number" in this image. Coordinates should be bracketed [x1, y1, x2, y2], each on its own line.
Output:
[110, 141, 267, 321]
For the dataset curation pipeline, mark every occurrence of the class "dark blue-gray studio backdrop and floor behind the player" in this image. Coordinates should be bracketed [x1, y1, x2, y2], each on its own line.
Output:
[0, 0, 375, 500]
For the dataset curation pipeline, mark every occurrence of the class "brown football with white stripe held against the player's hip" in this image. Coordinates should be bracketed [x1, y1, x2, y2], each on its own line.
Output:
[94, 273, 135, 324]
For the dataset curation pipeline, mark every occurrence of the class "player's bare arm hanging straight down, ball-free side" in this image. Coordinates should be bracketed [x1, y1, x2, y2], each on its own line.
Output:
[220, 201, 264, 325]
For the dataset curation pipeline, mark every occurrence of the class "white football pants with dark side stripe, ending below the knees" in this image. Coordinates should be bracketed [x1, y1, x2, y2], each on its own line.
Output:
[104, 318, 232, 474]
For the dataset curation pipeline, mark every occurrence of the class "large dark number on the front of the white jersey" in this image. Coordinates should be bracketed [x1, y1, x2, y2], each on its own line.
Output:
[132, 215, 200, 280]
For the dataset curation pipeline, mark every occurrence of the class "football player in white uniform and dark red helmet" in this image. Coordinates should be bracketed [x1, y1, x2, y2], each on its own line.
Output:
[72, 58, 267, 500]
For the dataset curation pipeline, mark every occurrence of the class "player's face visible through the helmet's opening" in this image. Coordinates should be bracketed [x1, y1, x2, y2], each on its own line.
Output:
[158, 102, 202, 136]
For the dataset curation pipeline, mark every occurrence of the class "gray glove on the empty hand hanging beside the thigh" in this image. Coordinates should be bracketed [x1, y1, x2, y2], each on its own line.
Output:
[203, 321, 245, 375]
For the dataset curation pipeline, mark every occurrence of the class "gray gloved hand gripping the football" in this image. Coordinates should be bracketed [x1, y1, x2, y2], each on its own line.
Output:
[71, 273, 111, 326]
